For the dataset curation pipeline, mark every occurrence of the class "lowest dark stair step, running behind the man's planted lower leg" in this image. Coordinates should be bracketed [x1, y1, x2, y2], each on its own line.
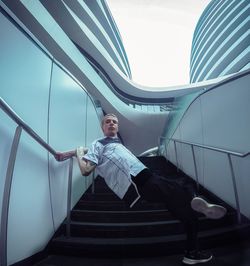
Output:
[52, 224, 250, 257]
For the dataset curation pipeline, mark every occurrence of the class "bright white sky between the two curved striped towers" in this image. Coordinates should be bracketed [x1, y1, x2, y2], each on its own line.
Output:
[106, 0, 211, 87]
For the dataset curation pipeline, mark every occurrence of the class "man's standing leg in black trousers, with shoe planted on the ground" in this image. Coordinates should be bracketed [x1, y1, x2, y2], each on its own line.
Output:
[138, 172, 212, 264]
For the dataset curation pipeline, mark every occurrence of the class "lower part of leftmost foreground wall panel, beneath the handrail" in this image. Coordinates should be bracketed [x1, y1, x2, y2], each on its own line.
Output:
[7, 133, 54, 264]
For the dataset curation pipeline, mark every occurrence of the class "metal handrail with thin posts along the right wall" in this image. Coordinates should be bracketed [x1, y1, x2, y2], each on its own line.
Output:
[160, 137, 250, 224]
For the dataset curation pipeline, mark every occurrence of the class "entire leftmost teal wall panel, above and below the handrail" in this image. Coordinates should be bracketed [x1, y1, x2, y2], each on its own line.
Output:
[0, 10, 53, 264]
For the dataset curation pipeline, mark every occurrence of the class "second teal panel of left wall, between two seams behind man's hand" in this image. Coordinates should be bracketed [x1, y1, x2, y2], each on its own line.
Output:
[49, 65, 87, 228]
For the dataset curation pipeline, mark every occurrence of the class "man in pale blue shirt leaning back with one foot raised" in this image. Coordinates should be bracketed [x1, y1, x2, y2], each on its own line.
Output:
[55, 114, 226, 264]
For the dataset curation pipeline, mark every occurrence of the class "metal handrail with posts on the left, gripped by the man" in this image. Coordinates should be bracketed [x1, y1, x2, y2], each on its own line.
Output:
[0, 97, 73, 266]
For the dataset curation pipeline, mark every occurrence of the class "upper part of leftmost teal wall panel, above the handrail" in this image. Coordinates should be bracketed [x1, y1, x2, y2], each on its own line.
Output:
[0, 10, 52, 140]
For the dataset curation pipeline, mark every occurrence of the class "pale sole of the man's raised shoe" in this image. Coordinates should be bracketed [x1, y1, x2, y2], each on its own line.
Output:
[191, 197, 227, 219]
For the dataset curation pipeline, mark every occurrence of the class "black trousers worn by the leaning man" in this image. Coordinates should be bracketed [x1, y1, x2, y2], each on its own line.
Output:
[132, 169, 198, 251]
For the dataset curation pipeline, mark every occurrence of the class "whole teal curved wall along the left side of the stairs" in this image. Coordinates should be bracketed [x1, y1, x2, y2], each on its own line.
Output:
[0, 9, 102, 265]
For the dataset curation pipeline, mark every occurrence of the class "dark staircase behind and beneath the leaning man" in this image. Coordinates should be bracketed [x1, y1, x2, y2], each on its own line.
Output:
[49, 157, 250, 257]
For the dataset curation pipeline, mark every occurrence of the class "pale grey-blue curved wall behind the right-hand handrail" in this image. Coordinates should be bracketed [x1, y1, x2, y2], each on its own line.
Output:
[163, 71, 250, 217]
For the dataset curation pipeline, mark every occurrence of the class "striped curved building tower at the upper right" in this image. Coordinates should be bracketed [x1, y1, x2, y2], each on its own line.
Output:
[190, 0, 250, 83]
